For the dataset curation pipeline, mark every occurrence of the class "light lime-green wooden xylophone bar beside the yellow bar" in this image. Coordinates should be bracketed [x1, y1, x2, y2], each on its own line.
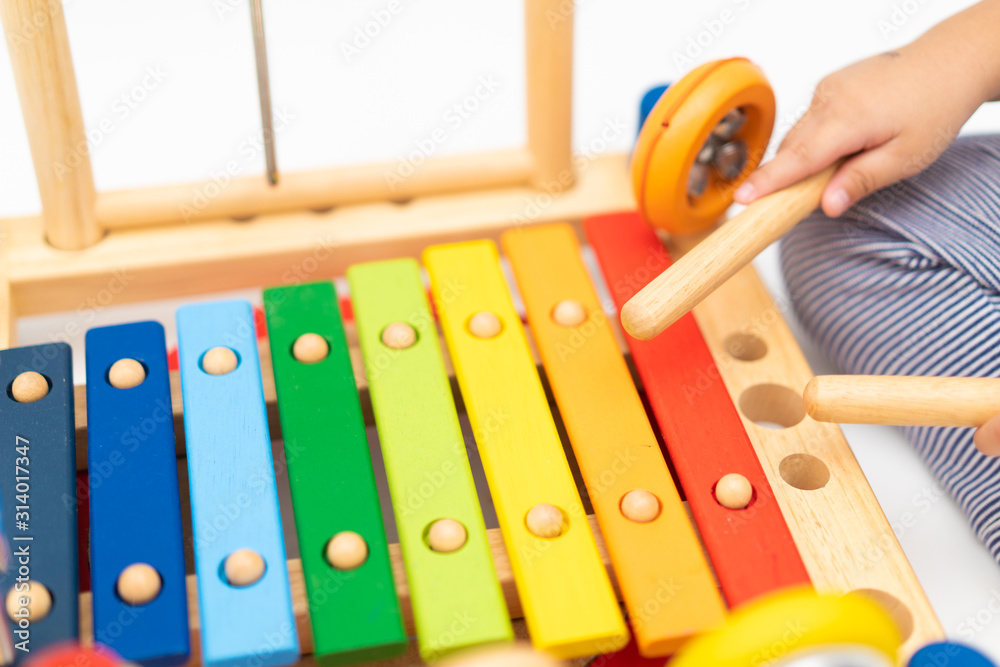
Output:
[347, 259, 513, 662]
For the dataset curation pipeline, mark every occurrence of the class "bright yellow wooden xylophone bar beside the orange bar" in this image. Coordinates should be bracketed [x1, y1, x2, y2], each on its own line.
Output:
[423, 241, 628, 658]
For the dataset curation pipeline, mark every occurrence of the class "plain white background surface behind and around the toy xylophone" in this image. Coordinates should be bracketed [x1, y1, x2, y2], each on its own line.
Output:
[0, 0, 1000, 660]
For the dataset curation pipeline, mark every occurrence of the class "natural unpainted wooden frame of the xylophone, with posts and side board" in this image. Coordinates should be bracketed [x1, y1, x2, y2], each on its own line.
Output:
[0, 0, 942, 664]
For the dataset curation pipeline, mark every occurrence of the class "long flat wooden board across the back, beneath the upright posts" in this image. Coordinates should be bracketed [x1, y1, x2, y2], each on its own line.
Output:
[0, 155, 634, 327]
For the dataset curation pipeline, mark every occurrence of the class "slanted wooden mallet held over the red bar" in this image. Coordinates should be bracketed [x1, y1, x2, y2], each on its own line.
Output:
[622, 162, 840, 340]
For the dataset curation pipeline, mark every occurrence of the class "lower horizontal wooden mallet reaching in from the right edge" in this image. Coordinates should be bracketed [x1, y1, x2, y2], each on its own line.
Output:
[803, 375, 1000, 427]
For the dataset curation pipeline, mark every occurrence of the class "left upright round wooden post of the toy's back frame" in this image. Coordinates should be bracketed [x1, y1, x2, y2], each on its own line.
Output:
[0, 0, 102, 250]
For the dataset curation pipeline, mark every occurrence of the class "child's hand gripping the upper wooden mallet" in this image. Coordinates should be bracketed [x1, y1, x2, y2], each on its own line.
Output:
[734, 0, 1000, 217]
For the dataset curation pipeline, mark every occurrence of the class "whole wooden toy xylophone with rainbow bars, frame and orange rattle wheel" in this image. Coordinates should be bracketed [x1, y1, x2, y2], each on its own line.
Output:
[0, 0, 972, 665]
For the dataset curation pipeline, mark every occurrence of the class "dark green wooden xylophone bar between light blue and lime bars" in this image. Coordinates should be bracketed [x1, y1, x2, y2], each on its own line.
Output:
[264, 281, 406, 665]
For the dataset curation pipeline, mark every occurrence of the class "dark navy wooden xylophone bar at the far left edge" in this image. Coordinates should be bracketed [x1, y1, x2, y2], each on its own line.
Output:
[0, 343, 79, 663]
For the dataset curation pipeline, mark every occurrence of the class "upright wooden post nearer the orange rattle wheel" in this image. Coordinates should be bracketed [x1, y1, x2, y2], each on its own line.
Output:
[524, 0, 575, 192]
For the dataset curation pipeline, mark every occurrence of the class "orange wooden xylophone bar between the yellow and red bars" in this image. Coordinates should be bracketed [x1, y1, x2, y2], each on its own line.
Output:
[501, 225, 725, 657]
